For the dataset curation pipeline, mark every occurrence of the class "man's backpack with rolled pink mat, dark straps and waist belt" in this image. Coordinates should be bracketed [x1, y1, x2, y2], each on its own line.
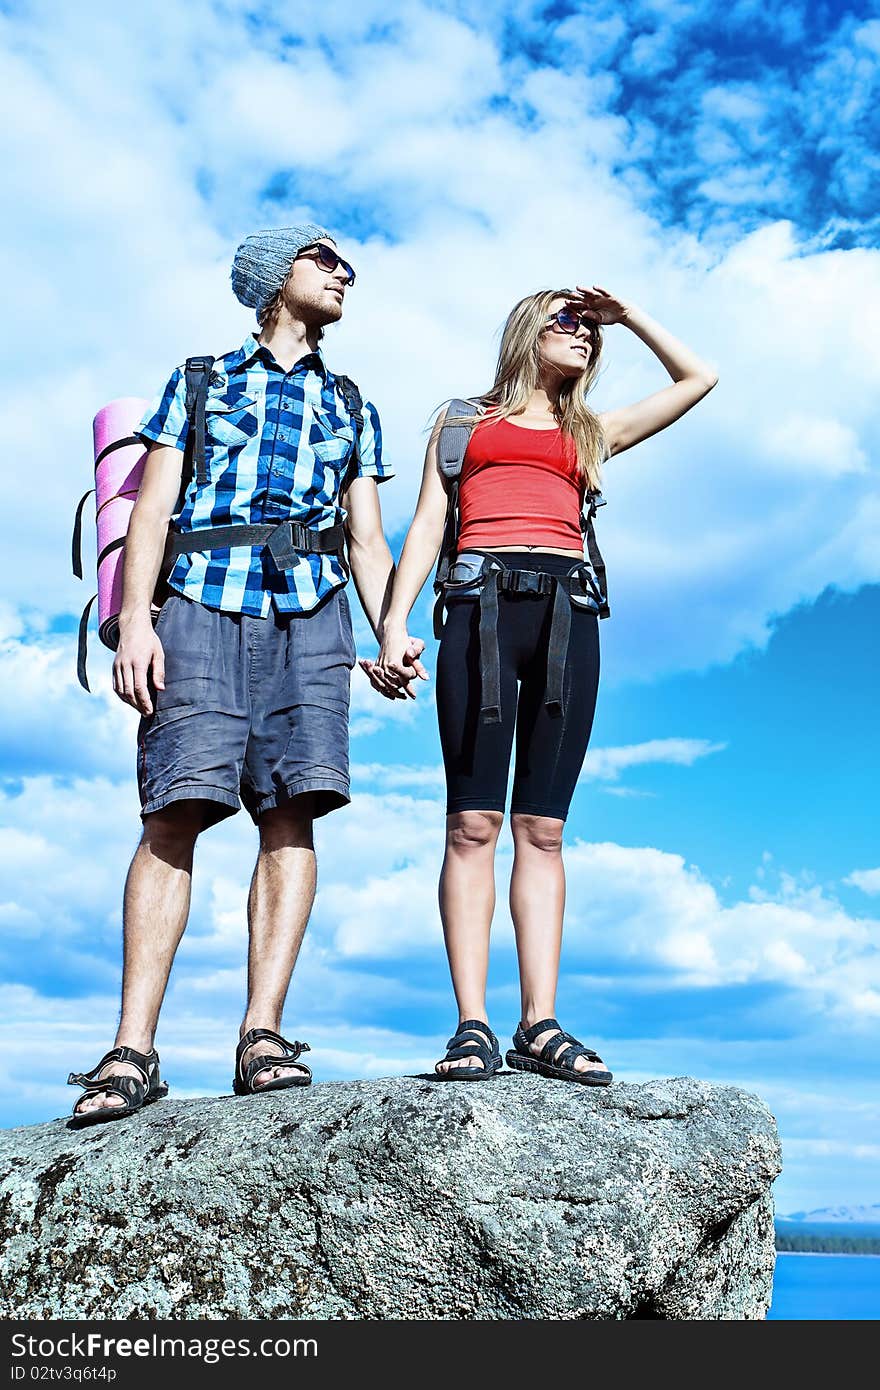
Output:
[71, 357, 364, 691]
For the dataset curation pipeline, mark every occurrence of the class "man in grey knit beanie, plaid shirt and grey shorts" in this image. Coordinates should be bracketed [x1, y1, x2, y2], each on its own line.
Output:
[71, 224, 424, 1125]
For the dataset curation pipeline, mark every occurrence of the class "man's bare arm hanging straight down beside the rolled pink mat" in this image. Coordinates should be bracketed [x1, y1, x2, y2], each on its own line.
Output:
[113, 445, 184, 714]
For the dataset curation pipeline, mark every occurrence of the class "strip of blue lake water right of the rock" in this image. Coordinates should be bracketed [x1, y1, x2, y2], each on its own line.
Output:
[767, 1252, 880, 1322]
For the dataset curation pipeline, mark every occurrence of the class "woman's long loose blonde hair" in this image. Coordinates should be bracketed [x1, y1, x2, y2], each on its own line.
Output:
[446, 289, 606, 489]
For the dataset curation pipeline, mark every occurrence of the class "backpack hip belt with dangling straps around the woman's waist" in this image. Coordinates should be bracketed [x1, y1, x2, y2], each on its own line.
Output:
[435, 555, 609, 724]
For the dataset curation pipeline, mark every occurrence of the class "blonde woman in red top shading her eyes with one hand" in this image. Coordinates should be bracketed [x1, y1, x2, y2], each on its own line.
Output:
[360, 285, 717, 1086]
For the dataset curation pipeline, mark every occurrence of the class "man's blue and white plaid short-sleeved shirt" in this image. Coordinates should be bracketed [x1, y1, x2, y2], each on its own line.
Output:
[135, 335, 392, 617]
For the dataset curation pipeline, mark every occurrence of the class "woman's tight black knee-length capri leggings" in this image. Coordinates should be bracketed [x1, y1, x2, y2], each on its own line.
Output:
[437, 546, 599, 820]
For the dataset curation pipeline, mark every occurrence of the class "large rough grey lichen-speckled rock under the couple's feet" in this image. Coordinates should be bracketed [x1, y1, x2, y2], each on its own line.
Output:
[0, 1074, 781, 1319]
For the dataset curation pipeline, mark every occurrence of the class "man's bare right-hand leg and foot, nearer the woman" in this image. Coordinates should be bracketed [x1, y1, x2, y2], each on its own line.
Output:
[239, 792, 317, 1090]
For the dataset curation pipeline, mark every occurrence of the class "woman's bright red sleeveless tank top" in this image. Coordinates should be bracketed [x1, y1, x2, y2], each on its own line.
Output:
[459, 420, 584, 550]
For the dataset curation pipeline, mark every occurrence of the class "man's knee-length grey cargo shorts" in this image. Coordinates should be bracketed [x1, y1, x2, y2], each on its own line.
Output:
[138, 589, 356, 827]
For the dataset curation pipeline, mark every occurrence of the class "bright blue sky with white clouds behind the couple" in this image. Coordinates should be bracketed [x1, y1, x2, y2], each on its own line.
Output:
[0, 0, 880, 1211]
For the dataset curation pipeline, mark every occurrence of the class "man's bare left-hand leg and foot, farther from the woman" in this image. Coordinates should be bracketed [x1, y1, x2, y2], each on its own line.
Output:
[76, 801, 204, 1113]
